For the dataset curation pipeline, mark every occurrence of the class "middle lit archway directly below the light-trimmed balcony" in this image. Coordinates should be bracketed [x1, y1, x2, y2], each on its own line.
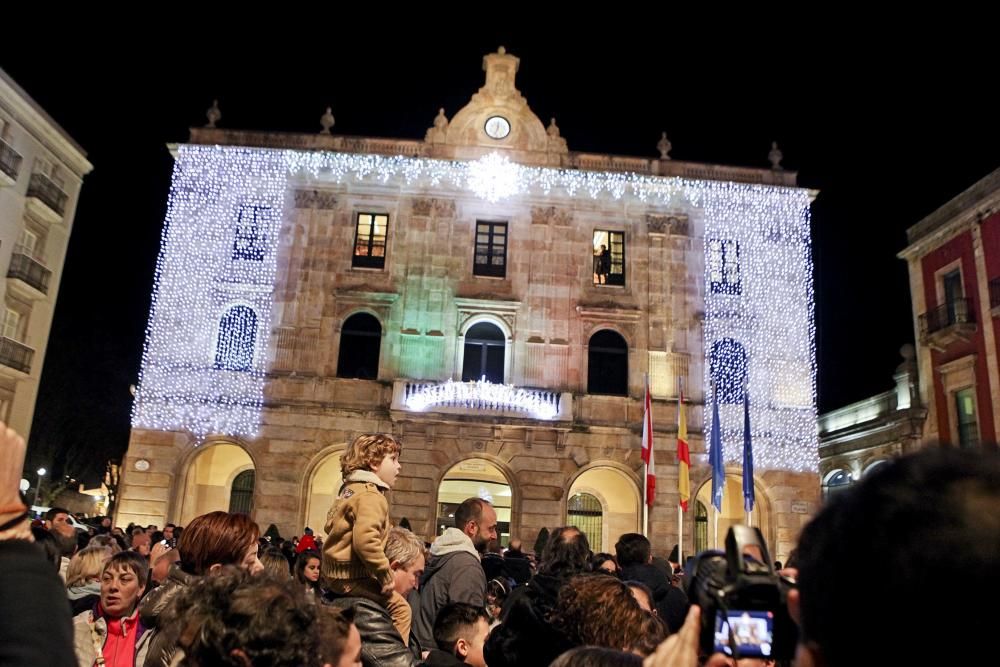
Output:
[435, 458, 513, 546]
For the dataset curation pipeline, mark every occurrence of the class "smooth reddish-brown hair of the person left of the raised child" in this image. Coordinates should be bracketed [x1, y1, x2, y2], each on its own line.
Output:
[177, 512, 260, 575]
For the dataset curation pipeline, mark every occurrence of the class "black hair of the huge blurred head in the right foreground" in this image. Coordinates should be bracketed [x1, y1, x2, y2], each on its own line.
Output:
[798, 449, 1000, 667]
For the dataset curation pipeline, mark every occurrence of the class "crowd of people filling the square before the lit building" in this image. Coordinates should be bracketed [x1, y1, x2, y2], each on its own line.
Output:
[0, 424, 1000, 667]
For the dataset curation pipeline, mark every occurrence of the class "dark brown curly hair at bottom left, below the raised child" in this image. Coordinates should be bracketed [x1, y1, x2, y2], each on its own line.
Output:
[159, 566, 323, 667]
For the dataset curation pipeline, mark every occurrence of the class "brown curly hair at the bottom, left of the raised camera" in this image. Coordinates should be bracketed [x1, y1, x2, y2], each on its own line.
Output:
[552, 574, 667, 655]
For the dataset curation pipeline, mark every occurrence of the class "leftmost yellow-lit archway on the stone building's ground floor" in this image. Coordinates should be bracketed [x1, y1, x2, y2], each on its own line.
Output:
[178, 443, 256, 525]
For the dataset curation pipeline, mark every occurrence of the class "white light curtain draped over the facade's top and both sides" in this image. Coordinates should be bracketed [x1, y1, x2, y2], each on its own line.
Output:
[133, 145, 817, 470]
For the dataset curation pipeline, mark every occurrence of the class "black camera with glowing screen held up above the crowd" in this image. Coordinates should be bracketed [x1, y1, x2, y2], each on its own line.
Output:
[685, 525, 798, 660]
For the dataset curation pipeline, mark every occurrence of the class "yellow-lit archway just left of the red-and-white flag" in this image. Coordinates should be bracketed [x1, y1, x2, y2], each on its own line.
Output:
[566, 466, 641, 552]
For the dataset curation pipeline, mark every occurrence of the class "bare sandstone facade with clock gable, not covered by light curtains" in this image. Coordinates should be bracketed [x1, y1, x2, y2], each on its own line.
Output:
[117, 50, 819, 557]
